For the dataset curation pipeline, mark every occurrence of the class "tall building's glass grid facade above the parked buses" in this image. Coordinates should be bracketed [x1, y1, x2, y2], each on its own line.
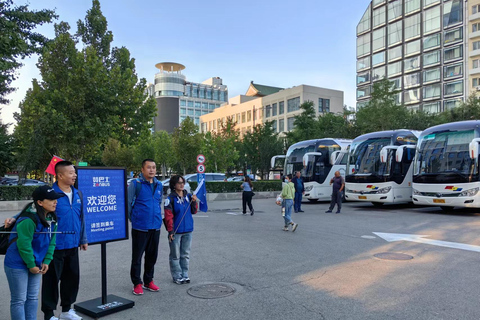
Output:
[356, 0, 466, 112]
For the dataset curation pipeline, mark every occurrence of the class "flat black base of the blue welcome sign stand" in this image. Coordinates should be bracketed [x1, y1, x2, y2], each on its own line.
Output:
[74, 294, 135, 319]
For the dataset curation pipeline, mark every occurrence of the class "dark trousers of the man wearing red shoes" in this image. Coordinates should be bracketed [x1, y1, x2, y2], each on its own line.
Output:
[130, 229, 160, 286]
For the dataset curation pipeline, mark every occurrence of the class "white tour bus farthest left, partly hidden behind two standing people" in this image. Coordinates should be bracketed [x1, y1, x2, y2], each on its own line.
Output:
[283, 138, 352, 202]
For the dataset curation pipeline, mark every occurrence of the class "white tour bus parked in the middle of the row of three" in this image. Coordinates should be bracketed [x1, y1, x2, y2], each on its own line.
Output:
[345, 129, 420, 206]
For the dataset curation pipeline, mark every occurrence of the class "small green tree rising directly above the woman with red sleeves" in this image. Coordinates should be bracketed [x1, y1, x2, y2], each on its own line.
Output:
[172, 117, 203, 175]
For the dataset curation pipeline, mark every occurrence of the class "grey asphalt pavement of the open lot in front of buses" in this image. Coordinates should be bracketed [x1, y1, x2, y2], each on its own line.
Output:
[0, 199, 480, 320]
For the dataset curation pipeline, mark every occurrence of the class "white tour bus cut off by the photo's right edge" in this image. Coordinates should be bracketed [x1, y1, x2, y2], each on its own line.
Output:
[413, 120, 480, 211]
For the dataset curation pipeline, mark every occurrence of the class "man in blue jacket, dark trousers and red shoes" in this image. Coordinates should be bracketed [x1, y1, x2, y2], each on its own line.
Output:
[128, 159, 163, 295]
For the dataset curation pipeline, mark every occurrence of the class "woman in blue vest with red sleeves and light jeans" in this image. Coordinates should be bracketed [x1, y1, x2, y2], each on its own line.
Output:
[164, 175, 198, 284]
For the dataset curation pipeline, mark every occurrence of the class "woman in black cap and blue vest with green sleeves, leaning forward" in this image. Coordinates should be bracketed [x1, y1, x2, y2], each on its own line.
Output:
[4, 185, 62, 320]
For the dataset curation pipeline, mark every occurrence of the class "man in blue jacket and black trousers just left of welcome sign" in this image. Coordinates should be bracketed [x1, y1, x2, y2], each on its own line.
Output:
[42, 161, 88, 320]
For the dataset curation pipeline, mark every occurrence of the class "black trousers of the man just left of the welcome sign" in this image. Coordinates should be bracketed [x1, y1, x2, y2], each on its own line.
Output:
[42, 248, 80, 320]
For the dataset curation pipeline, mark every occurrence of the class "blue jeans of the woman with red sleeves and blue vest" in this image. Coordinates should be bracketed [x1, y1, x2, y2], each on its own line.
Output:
[169, 232, 192, 280]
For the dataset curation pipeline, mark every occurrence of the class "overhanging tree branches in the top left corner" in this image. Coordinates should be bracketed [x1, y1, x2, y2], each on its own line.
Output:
[0, 0, 57, 104]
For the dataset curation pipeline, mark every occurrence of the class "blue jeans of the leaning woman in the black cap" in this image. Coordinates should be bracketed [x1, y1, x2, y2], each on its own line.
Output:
[5, 266, 42, 320]
